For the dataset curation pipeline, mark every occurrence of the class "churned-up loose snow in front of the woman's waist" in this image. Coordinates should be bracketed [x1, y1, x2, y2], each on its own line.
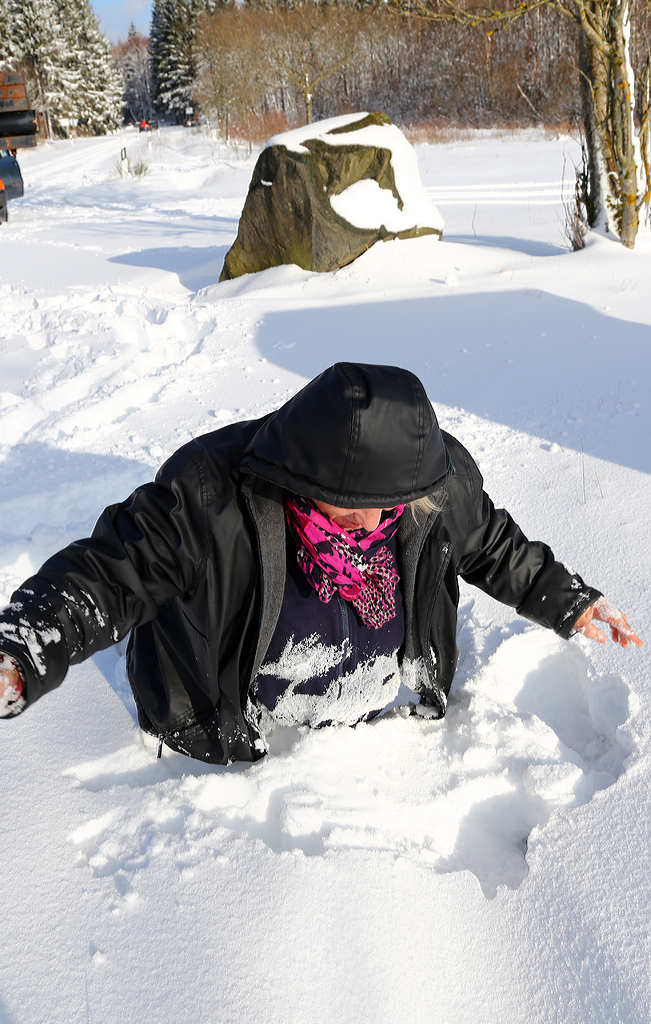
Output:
[67, 630, 633, 898]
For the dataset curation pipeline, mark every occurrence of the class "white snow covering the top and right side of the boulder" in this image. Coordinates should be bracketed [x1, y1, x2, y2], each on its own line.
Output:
[267, 112, 444, 233]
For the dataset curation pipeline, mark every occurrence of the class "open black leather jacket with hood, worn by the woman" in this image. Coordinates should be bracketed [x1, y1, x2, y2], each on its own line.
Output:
[0, 364, 600, 763]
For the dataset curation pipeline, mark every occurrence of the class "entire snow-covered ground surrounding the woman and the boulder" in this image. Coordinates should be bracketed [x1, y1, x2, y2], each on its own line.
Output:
[0, 129, 651, 1024]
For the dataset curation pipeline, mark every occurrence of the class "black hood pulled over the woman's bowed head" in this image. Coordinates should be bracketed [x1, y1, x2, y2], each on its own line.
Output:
[241, 362, 451, 508]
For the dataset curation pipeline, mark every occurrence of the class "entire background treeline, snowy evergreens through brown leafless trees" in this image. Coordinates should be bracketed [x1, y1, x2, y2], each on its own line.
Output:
[0, 0, 651, 142]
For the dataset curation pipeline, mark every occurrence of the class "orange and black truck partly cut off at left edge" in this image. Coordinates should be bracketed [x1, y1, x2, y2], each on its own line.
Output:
[0, 72, 38, 223]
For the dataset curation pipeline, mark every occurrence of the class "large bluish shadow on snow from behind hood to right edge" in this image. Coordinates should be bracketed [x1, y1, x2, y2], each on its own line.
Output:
[251, 290, 651, 472]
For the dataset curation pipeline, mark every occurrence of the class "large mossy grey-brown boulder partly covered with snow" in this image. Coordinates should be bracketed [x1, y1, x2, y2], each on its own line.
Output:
[219, 114, 443, 281]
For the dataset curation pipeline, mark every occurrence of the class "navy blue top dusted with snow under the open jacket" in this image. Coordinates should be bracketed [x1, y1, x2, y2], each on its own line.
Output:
[252, 529, 404, 725]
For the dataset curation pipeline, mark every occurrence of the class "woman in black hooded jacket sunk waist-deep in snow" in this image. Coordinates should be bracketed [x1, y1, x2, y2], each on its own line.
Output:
[0, 364, 642, 764]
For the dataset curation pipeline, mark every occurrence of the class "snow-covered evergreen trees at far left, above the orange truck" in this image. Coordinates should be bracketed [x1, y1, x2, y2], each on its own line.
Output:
[0, 0, 123, 135]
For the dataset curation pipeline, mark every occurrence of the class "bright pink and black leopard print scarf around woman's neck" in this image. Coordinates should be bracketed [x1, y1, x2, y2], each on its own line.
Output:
[285, 493, 404, 630]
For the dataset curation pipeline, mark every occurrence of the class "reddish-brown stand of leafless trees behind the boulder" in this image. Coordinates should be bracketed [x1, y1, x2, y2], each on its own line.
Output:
[192, 4, 580, 140]
